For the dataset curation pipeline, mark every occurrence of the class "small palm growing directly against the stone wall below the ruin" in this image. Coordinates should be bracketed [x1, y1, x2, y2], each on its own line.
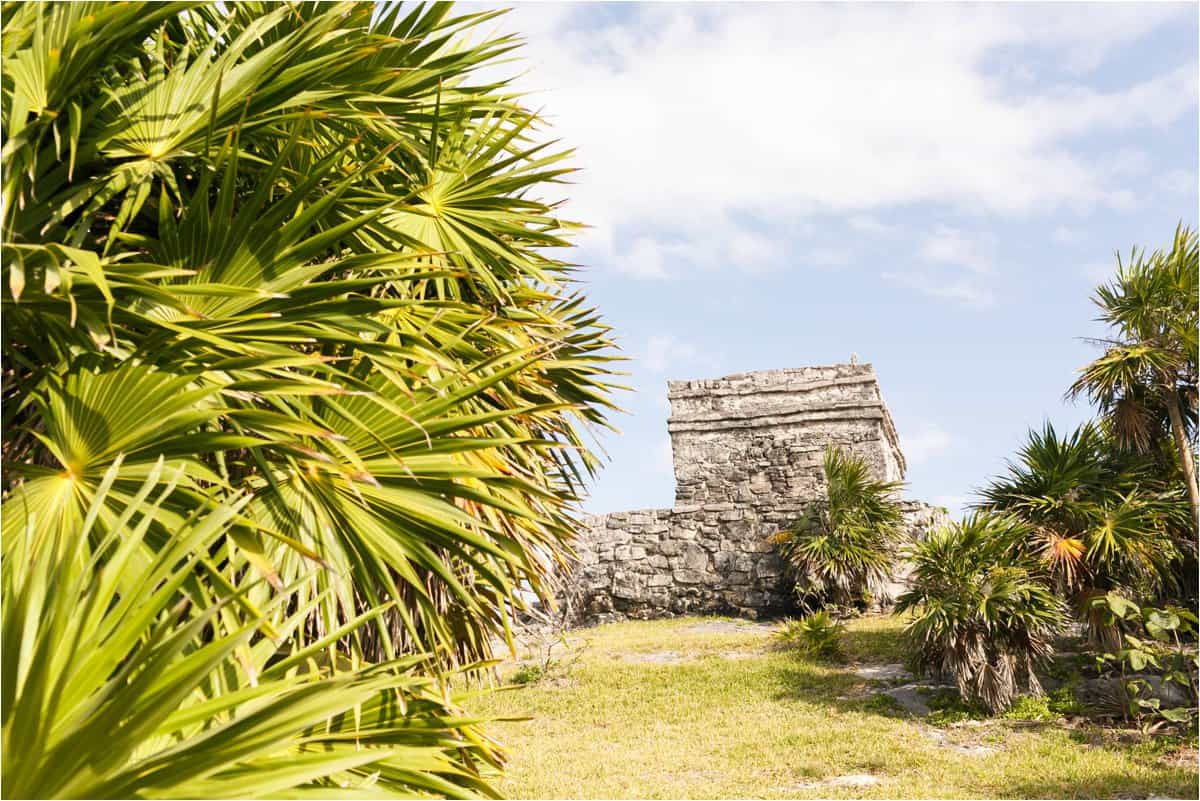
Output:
[772, 446, 904, 604]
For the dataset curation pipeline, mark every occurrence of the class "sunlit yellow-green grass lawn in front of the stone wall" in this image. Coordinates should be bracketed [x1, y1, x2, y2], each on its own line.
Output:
[472, 618, 1196, 799]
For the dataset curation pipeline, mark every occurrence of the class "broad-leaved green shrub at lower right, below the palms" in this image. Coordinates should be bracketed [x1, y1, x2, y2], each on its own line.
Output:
[1092, 592, 1200, 729]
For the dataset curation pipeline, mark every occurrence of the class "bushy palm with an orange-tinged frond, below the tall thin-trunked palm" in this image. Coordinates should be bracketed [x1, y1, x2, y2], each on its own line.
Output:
[979, 422, 1188, 639]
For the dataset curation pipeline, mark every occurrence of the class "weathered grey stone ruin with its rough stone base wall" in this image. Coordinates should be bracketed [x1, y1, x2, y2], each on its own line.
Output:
[563, 365, 946, 622]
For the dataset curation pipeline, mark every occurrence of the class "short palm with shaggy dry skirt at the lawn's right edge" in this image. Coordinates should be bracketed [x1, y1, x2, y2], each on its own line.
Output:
[896, 514, 1063, 712]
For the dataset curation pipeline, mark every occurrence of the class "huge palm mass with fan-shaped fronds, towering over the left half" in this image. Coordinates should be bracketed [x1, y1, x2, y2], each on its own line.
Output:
[0, 1, 616, 795]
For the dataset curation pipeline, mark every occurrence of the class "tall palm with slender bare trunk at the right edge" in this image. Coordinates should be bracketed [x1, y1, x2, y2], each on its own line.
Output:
[1068, 224, 1200, 520]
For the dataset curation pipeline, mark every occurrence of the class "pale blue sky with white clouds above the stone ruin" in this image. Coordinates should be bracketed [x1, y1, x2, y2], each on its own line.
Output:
[470, 4, 1200, 512]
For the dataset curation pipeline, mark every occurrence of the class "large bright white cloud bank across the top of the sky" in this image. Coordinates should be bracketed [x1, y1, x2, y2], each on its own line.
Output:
[472, 4, 1196, 281]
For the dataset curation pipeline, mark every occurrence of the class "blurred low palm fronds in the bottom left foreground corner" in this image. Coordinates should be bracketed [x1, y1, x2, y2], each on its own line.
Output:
[0, 459, 499, 799]
